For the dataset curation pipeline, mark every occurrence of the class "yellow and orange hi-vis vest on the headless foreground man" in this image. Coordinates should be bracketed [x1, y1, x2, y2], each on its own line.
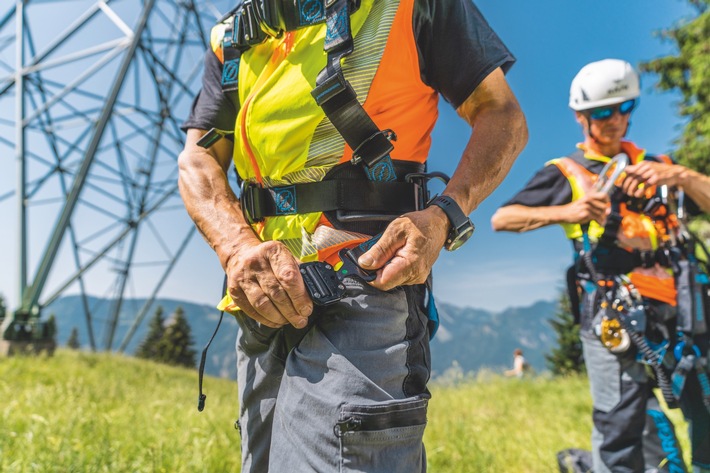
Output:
[211, 0, 438, 262]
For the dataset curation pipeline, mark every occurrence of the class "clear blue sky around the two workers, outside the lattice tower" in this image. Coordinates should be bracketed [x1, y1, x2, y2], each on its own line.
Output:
[0, 0, 694, 310]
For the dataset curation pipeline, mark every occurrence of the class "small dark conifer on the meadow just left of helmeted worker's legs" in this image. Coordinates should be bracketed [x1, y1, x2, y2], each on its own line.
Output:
[545, 290, 586, 376]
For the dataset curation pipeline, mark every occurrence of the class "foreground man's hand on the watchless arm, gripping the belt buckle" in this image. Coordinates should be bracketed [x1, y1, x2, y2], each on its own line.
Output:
[226, 241, 313, 328]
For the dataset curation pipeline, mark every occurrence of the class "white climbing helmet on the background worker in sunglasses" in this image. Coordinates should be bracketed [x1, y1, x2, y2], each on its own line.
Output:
[569, 59, 640, 111]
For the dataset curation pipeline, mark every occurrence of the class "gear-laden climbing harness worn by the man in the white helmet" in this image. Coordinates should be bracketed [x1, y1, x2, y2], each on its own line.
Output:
[577, 153, 710, 412]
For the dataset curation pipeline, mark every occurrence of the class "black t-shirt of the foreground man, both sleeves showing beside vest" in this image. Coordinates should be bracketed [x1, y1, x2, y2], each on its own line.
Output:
[182, 0, 515, 131]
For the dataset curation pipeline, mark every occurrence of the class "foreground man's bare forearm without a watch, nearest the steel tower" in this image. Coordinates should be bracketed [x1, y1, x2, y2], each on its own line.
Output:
[178, 136, 259, 268]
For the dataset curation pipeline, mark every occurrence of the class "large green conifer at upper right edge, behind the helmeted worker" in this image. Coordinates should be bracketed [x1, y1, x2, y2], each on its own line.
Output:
[641, 0, 710, 174]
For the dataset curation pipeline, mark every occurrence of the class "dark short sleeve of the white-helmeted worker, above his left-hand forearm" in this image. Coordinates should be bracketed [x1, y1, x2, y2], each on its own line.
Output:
[503, 164, 572, 207]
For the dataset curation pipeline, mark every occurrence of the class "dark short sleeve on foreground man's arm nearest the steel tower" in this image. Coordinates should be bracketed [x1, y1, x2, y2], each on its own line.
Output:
[180, 50, 237, 131]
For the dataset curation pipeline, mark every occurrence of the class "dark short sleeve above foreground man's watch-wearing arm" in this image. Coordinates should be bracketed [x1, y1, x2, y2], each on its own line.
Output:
[413, 0, 515, 108]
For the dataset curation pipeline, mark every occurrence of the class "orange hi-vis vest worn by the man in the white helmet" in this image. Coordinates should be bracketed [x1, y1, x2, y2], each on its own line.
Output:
[546, 141, 678, 305]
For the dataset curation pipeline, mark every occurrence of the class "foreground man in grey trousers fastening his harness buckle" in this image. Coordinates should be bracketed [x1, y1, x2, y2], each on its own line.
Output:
[179, 0, 527, 466]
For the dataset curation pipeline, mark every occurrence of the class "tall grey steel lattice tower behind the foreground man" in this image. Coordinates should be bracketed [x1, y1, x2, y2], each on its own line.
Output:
[0, 0, 229, 350]
